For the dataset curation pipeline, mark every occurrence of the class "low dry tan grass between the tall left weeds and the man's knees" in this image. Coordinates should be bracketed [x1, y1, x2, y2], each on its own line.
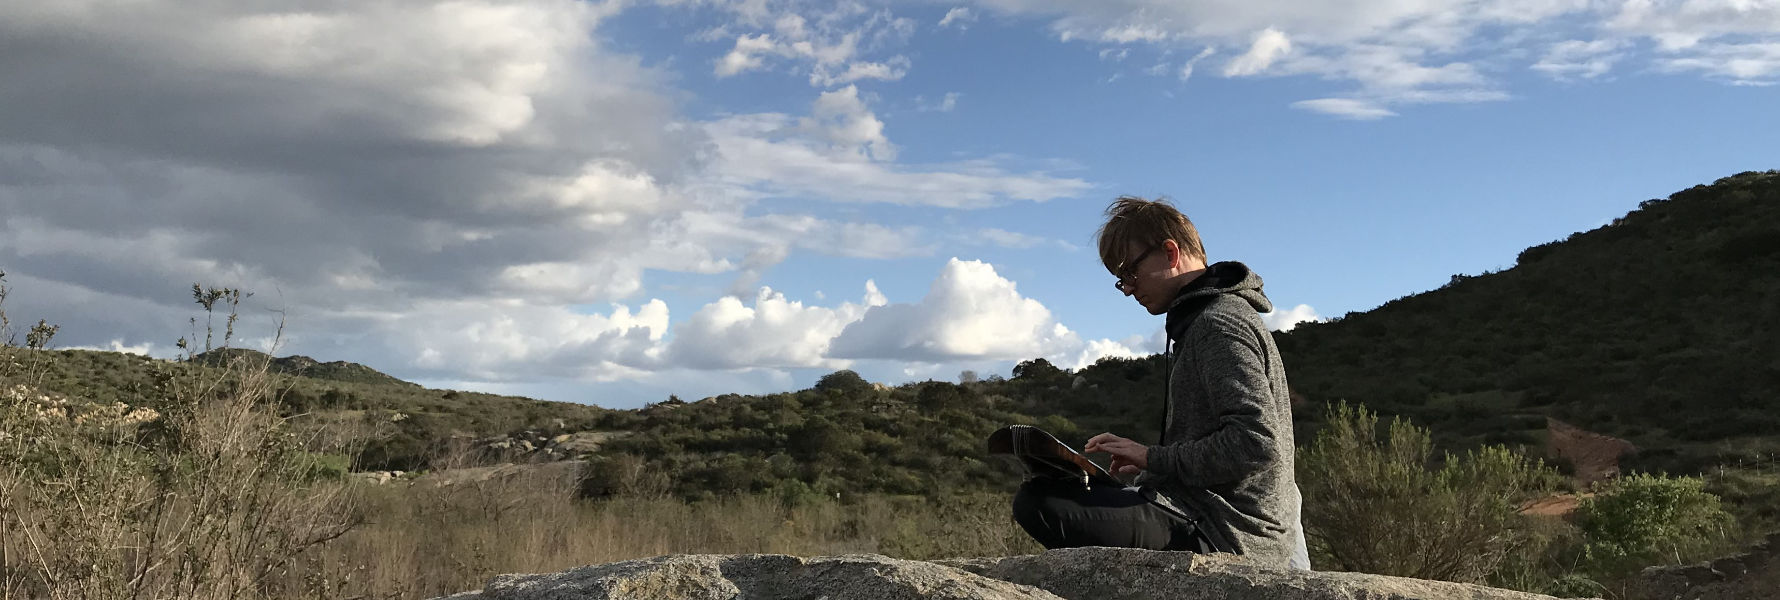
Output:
[290, 475, 1041, 598]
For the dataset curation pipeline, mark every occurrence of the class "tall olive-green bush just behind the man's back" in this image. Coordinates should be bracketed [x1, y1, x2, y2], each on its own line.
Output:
[1298, 402, 1558, 582]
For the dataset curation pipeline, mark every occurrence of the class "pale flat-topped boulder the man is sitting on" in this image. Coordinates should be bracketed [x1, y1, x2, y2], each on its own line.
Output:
[437, 548, 1580, 600]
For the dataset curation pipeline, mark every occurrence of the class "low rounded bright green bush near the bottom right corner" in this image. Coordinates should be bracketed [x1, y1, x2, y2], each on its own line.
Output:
[1577, 474, 1736, 575]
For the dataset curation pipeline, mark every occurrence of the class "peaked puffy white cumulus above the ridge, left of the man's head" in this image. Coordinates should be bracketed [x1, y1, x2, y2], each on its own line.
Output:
[829, 258, 1080, 361]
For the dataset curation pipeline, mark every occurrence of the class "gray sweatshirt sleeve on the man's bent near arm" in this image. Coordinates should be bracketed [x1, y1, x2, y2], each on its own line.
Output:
[1146, 313, 1278, 488]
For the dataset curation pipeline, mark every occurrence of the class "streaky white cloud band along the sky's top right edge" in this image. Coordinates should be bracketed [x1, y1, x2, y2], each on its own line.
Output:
[974, 0, 1780, 113]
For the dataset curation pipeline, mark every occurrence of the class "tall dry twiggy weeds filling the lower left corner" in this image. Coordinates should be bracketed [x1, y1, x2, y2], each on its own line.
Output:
[0, 281, 356, 600]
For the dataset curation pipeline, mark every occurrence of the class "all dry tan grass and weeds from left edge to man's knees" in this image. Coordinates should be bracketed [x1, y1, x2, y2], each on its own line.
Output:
[0, 272, 1038, 600]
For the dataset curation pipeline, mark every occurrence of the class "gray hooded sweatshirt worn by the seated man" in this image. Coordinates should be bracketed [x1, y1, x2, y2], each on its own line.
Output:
[1137, 262, 1310, 568]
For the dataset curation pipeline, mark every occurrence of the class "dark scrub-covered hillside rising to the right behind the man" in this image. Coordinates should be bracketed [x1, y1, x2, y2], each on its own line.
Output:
[1276, 171, 1780, 472]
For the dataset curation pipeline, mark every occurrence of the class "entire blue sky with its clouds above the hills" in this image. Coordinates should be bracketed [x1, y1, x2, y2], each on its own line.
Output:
[0, 0, 1780, 408]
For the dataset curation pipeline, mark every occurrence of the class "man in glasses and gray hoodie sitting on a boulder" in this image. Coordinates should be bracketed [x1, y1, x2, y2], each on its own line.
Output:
[1015, 196, 1310, 568]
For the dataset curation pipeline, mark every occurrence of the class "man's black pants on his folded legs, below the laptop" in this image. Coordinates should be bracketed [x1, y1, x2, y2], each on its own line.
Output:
[1013, 477, 1210, 552]
